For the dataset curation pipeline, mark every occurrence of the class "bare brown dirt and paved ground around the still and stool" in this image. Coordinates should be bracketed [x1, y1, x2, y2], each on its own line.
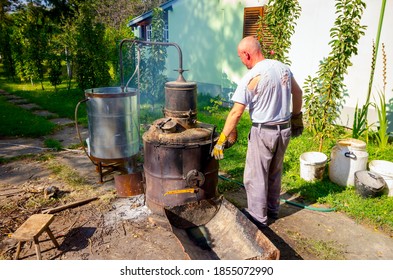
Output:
[0, 92, 393, 260]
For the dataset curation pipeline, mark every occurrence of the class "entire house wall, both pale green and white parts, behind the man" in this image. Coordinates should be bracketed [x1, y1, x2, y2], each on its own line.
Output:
[163, 0, 393, 131]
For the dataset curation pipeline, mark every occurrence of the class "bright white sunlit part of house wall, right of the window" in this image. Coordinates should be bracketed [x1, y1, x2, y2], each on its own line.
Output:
[289, 0, 393, 130]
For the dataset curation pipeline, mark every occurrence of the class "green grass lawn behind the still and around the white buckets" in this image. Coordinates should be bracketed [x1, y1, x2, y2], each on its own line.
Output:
[0, 71, 393, 234]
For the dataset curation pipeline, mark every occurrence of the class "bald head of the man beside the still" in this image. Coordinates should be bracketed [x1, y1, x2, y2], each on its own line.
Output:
[237, 36, 265, 69]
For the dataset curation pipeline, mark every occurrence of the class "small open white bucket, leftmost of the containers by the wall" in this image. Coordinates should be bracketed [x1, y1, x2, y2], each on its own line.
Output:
[300, 152, 327, 181]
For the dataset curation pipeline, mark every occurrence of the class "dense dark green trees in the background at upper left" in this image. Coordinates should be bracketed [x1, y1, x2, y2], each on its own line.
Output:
[0, 0, 165, 89]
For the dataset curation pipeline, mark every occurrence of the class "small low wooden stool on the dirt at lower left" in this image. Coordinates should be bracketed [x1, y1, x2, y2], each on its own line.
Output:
[11, 214, 59, 260]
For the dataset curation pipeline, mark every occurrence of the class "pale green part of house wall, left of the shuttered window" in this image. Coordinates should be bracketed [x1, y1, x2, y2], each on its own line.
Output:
[167, 0, 246, 94]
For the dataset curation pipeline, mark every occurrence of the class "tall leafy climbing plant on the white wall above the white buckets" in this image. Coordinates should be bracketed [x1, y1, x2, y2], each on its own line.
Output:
[304, 0, 366, 151]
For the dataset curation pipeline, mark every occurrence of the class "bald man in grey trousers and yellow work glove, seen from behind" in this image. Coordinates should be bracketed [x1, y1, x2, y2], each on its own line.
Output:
[212, 36, 303, 227]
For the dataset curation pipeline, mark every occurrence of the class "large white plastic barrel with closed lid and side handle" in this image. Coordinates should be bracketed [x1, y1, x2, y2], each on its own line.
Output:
[329, 138, 368, 186]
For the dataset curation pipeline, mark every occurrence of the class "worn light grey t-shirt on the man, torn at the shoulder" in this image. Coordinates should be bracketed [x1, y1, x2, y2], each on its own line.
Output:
[232, 59, 292, 123]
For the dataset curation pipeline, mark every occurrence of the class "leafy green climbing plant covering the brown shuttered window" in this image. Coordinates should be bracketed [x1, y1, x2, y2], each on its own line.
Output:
[257, 0, 301, 64]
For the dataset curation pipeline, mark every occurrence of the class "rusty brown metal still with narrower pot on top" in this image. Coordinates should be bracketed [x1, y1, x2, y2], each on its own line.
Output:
[143, 82, 219, 215]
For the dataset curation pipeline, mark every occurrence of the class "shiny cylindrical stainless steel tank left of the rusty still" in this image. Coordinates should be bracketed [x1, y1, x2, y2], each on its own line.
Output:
[85, 87, 140, 162]
